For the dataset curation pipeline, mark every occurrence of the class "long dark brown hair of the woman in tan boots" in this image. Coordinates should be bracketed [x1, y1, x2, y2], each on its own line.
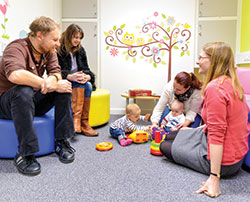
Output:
[57, 24, 84, 55]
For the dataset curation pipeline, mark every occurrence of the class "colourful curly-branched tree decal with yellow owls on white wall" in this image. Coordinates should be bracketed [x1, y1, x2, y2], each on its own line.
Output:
[104, 12, 191, 81]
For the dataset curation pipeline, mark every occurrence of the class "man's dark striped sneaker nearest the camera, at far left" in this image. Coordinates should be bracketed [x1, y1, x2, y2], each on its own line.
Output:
[14, 154, 41, 175]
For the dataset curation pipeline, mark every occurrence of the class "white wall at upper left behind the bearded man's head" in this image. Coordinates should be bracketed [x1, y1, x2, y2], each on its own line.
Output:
[0, 0, 61, 54]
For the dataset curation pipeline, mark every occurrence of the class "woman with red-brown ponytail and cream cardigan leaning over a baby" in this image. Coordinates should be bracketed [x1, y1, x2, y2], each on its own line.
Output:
[151, 72, 202, 128]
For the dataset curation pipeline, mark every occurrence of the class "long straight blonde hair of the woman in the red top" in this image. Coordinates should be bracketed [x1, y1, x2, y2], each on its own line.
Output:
[202, 42, 244, 100]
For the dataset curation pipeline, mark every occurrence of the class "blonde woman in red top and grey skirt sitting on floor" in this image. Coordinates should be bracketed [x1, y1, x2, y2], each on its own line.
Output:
[160, 42, 250, 197]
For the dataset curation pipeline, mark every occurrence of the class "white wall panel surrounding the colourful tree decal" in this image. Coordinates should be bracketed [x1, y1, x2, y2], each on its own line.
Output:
[99, 0, 195, 114]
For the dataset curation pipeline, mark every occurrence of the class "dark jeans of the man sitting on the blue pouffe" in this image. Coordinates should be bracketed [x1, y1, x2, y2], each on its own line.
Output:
[0, 85, 74, 156]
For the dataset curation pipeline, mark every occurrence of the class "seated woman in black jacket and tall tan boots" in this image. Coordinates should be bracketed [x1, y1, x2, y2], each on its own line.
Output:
[57, 24, 98, 136]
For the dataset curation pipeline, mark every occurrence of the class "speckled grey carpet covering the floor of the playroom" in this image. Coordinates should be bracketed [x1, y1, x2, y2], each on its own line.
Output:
[0, 115, 250, 202]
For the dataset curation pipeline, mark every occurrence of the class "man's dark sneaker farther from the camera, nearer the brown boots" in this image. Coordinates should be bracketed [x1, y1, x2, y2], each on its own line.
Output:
[55, 140, 76, 163]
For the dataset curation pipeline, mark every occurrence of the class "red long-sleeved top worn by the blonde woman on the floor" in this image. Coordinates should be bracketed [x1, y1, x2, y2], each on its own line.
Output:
[202, 76, 250, 165]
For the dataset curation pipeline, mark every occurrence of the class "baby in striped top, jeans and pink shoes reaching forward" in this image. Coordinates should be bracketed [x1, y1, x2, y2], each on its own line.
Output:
[109, 103, 151, 146]
